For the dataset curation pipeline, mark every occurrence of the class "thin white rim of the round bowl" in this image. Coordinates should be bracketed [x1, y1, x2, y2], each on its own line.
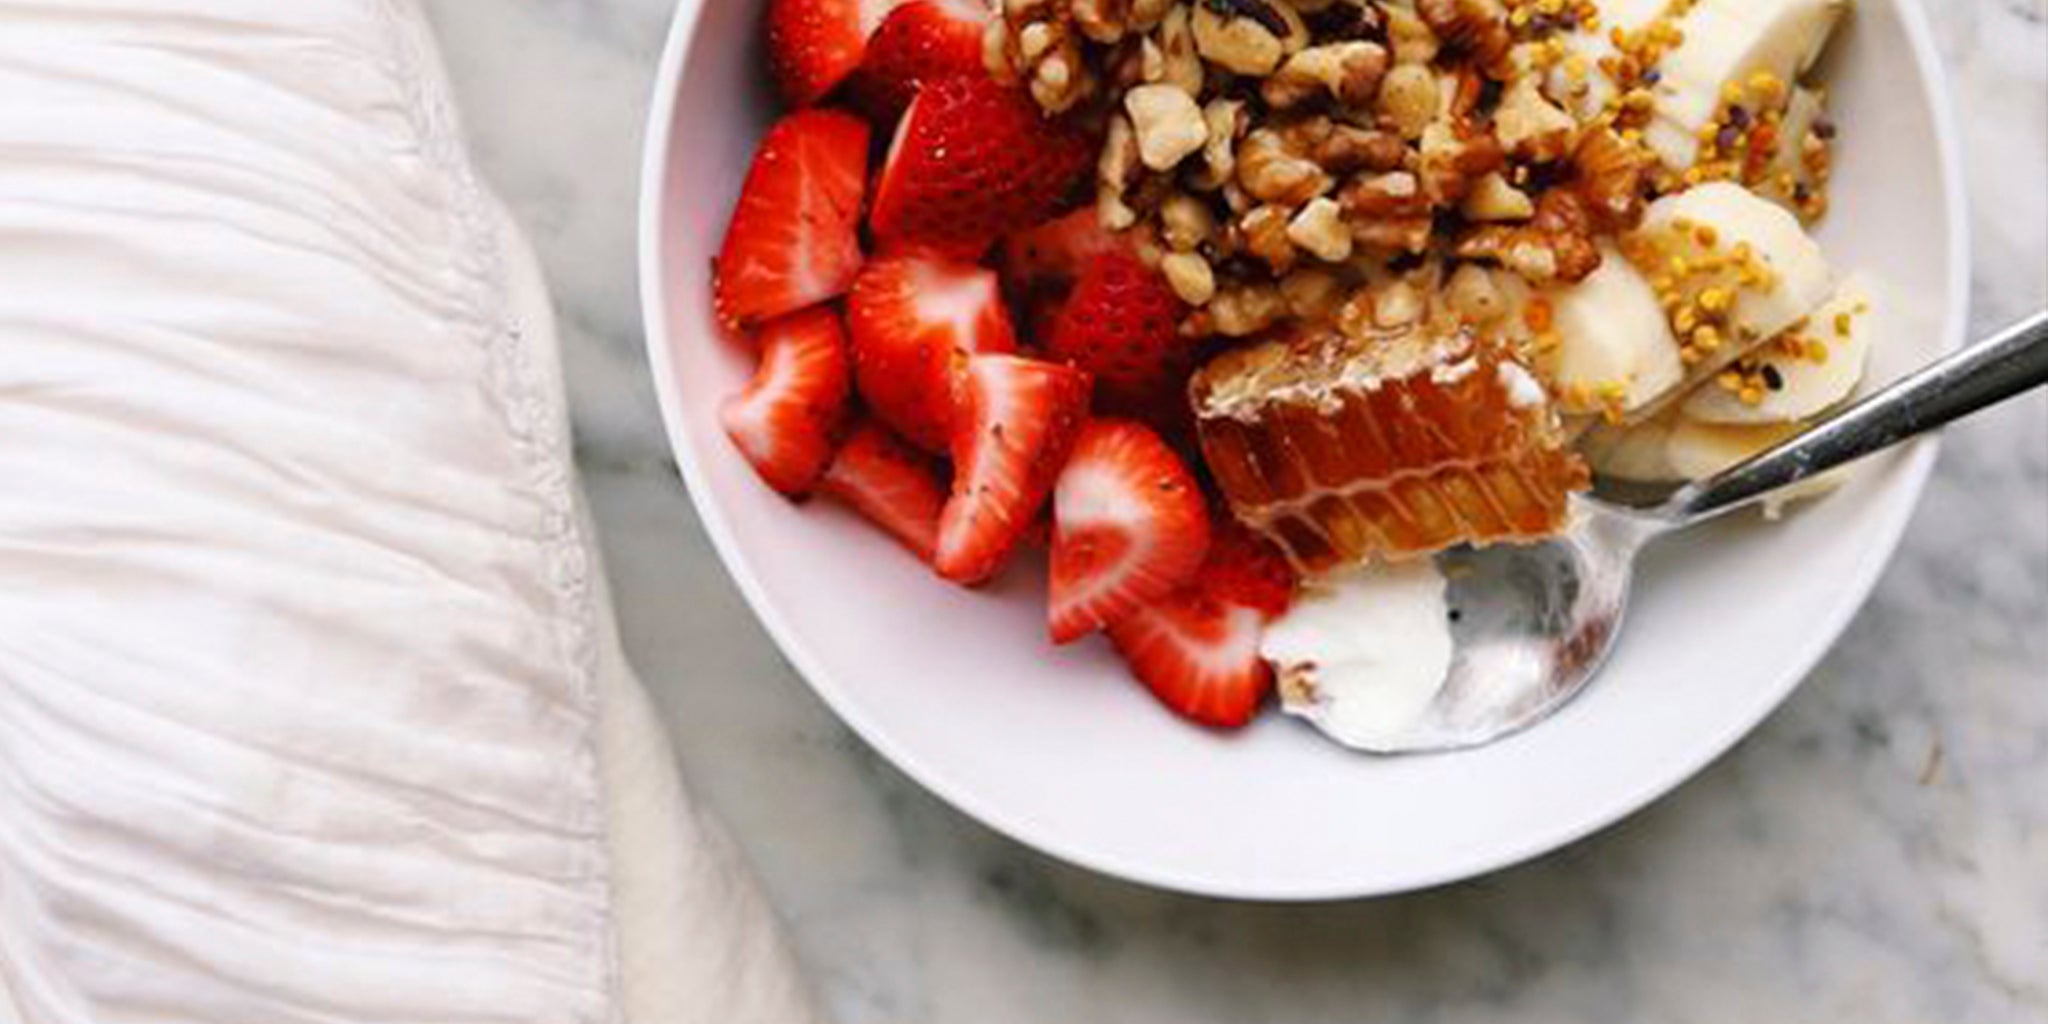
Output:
[637, 0, 1970, 903]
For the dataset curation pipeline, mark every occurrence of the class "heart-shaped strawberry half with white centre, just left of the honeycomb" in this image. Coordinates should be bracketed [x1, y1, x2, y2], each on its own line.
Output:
[1047, 420, 1208, 643]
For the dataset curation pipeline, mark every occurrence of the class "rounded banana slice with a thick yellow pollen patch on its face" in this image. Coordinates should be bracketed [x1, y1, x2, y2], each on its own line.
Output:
[1622, 182, 1835, 381]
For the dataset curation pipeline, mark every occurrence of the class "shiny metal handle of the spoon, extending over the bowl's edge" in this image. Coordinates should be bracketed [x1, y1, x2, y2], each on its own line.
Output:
[1665, 311, 2048, 524]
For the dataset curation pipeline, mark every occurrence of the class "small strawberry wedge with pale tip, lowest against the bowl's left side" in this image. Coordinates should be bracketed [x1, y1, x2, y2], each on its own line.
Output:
[719, 309, 850, 496]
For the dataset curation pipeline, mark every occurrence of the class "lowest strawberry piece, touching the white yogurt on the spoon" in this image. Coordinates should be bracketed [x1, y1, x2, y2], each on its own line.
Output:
[1110, 586, 1274, 729]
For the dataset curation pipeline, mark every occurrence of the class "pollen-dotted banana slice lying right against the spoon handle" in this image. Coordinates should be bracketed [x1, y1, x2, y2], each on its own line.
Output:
[1683, 276, 1874, 424]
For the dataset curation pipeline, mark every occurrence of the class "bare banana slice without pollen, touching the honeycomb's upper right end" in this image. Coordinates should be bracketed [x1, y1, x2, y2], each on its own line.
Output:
[1550, 244, 1686, 414]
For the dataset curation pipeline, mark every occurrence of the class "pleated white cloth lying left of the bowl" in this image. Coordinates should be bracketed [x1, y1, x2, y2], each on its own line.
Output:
[0, 0, 817, 1024]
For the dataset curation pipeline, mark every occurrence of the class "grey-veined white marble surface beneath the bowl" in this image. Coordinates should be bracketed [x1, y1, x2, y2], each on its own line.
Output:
[428, 0, 2048, 1024]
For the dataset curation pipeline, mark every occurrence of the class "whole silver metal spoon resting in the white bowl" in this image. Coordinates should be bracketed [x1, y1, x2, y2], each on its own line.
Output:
[1374, 313, 2048, 754]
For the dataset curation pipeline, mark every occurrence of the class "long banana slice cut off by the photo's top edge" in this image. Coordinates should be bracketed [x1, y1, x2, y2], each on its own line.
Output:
[1642, 0, 1849, 170]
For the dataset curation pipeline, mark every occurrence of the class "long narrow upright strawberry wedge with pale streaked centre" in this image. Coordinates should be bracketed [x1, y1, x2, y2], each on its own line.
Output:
[934, 356, 1087, 586]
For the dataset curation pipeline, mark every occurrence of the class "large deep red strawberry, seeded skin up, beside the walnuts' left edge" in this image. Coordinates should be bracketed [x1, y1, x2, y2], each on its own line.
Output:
[868, 74, 1094, 258]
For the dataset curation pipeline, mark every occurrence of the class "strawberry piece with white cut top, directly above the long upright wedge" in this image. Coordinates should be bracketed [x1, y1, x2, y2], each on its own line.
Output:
[846, 254, 1016, 453]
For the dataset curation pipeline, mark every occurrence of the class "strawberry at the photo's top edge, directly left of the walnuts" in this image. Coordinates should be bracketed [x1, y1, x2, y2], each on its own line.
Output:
[852, 0, 989, 123]
